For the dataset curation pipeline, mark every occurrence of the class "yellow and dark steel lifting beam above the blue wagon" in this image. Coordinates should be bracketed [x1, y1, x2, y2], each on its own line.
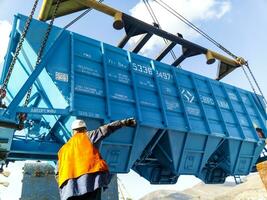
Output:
[39, 0, 245, 80]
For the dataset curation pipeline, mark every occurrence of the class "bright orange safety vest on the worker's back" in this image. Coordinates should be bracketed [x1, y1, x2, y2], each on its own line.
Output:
[58, 132, 108, 187]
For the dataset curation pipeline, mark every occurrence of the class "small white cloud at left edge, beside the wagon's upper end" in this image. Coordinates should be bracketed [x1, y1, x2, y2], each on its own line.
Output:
[0, 20, 11, 64]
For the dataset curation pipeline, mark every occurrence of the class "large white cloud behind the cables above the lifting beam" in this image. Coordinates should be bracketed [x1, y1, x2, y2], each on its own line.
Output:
[130, 0, 231, 54]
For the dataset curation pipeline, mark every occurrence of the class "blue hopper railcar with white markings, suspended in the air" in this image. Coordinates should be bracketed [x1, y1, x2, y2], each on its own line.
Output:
[2, 15, 266, 184]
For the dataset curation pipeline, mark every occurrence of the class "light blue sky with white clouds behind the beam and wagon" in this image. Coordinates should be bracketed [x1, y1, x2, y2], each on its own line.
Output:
[0, 0, 267, 200]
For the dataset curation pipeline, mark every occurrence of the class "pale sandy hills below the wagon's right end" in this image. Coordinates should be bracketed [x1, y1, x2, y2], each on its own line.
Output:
[140, 173, 267, 200]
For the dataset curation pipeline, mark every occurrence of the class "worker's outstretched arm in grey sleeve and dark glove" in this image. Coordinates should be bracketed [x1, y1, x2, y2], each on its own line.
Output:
[89, 118, 136, 143]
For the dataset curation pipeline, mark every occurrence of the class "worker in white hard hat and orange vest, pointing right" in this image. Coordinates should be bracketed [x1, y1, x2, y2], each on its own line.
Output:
[58, 118, 136, 200]
